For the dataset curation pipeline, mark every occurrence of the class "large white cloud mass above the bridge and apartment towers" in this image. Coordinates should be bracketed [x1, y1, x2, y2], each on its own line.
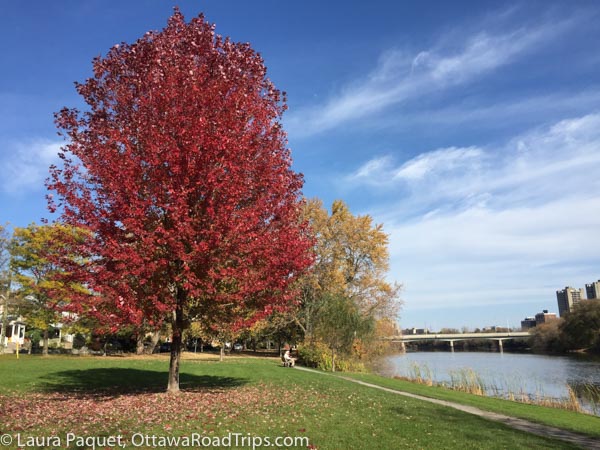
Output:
[346, 114, 600, 313]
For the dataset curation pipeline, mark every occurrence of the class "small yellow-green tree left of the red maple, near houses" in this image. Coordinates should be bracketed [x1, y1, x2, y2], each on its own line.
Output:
[10, 224, 87, 355]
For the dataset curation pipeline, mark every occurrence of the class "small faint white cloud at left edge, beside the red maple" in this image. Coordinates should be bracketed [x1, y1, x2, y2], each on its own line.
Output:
[0, 139, 62, 193]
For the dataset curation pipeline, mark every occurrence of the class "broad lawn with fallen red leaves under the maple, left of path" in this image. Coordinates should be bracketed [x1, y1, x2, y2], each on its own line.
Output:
[0, 356, 592, 450]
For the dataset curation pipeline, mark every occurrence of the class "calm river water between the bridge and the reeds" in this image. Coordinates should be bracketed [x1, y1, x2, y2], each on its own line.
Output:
[377, 352, 600, 414]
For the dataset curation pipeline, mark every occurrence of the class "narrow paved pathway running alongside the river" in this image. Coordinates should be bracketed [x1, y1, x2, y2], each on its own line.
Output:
[296, 366, 600, 449]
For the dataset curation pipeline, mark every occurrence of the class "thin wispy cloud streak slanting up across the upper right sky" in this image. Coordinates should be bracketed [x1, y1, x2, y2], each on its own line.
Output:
[286, 19, 574, 136]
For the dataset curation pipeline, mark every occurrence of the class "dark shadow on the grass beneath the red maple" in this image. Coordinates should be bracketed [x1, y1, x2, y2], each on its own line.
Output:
[40, 367, 247, 396]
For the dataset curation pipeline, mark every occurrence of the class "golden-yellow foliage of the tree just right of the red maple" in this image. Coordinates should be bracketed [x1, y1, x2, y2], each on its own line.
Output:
[298, 199, 400, 339]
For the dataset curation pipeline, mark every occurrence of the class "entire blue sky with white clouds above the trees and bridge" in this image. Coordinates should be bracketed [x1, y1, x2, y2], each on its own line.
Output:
[0, 0, 600, 328]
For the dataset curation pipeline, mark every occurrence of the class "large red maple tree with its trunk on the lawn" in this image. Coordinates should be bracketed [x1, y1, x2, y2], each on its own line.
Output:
[47, 9, 311, 392]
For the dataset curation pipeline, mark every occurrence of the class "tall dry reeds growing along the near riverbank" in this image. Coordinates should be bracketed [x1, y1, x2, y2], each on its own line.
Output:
[394, 364, 600, 415]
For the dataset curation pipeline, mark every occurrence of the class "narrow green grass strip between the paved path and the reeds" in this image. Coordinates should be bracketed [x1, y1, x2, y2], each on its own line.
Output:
[342, 374, 600, 438]
